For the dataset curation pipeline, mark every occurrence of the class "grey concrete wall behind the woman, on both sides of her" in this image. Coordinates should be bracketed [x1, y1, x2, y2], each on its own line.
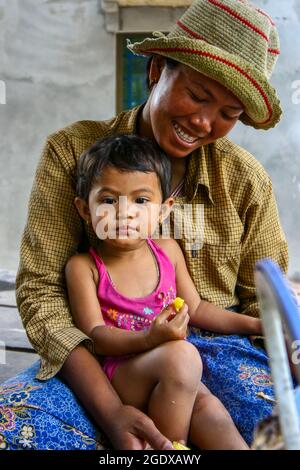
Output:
[0, 0, 300, 273]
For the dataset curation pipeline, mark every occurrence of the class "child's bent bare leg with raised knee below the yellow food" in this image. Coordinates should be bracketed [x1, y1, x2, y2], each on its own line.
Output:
[112, 341, 202, 441]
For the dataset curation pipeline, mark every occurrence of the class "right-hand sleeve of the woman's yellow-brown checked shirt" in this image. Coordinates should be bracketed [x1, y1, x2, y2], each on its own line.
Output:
[236, 180, 288, 317]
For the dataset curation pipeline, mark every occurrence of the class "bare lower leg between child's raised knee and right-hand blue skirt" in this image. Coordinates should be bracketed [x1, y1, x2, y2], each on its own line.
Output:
[190, 383, 249, 450]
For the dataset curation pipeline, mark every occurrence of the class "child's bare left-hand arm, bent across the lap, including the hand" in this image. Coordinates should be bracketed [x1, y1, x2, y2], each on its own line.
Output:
[65, 254, 188, 356]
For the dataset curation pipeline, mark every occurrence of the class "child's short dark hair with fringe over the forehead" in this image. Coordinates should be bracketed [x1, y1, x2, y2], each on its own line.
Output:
[76, 134, 171, 202]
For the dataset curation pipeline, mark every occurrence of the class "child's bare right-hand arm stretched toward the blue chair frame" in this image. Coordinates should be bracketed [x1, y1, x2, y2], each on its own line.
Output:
[165, 240, 262, 335]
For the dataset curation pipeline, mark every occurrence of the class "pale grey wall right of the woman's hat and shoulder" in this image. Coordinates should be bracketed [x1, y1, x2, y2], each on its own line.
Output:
[231, 0, 300, 275]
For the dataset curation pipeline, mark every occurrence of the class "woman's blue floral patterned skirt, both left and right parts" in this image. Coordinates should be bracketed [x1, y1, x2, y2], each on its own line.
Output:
[0, 328, 273, 450]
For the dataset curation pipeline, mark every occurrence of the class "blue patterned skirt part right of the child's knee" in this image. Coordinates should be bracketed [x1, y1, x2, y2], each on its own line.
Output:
[188, 328, 274, 444]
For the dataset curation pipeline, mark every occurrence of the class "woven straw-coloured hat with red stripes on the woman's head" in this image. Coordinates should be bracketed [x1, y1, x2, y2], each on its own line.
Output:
[127, 0, 281, 129]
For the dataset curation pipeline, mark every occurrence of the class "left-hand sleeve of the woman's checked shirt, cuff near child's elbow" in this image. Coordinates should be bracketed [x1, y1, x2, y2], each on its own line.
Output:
[16, 134, 93, 380]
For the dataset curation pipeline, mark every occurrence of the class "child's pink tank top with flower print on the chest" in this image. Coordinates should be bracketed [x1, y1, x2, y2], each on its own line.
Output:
[89, 239, 176, 331]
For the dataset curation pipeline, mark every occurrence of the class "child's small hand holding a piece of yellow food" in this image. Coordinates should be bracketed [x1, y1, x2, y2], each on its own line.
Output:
[146, 304, 190, 349]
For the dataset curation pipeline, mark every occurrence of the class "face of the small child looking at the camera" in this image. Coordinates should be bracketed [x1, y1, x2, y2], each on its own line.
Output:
[75, 167, 173, 246]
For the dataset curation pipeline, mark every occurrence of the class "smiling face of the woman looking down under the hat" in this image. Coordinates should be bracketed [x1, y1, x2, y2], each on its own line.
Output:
[139, 57, 244, 157]
